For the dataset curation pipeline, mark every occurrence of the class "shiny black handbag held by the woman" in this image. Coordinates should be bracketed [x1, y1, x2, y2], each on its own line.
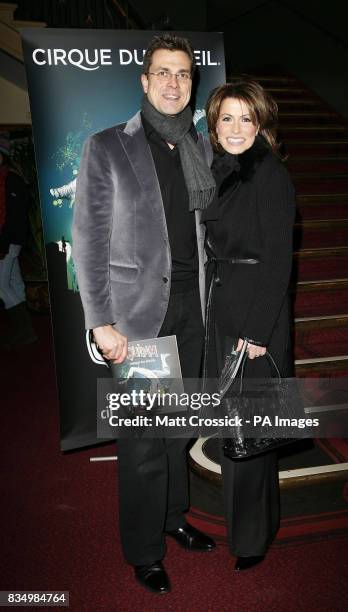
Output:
[219, 341, 308, 459]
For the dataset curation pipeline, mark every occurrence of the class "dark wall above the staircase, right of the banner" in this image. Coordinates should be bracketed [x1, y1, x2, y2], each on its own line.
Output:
[212, 2, 348, 118]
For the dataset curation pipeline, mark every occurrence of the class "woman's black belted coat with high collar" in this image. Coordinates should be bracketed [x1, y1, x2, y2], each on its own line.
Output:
[202, 136, 295, 376]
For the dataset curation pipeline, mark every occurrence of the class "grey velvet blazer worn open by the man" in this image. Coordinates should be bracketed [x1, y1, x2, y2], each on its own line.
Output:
[72, 112, 212, 340]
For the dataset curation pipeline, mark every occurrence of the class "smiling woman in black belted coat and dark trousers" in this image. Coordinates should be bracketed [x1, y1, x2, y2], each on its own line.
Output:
[202, 79, 295, 570]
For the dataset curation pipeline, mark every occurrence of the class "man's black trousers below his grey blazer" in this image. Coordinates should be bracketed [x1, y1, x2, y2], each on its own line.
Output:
[117, 288, 204, 565]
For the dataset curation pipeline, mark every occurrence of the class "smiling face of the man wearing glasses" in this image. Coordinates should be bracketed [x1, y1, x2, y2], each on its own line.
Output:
[141, 49, 192, 115]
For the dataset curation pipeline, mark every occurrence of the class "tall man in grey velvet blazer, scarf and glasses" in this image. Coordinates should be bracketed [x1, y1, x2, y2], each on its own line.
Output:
[73, 34, 215, 593]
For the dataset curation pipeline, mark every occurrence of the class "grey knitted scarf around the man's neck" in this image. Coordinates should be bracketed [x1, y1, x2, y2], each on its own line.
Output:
[141, 96, 215, 210]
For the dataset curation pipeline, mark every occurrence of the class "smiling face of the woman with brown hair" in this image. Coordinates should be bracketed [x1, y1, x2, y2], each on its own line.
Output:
[216, 98, 259, 155]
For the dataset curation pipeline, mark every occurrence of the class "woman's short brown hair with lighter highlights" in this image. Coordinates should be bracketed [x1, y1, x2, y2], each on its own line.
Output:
[206, 77, 279, 156]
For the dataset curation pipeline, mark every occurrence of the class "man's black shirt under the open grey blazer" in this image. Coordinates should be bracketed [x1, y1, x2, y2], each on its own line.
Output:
[142, 115, 198, 293]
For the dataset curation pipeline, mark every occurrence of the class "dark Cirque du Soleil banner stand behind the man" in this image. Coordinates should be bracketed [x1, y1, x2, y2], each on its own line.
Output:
[21, 28, 226, 450]
